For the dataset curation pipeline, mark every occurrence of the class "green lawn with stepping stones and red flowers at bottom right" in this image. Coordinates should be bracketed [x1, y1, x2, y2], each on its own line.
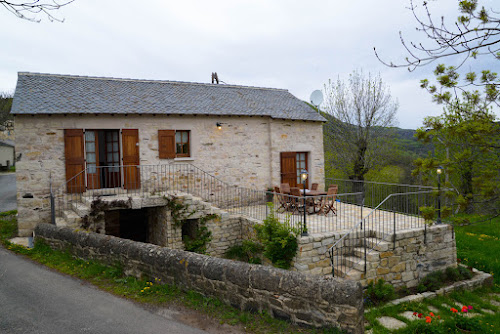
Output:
[366, 216, 500, 333]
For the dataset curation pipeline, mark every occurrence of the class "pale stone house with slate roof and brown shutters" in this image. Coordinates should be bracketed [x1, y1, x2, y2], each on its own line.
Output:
[12, 72, 325, 236]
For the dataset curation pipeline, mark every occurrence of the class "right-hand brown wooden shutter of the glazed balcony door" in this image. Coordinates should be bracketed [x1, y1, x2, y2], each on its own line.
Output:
[122, 129, 141, 189]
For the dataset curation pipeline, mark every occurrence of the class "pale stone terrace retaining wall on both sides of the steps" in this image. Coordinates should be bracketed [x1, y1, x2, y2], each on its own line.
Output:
[293, 225, 457, 287]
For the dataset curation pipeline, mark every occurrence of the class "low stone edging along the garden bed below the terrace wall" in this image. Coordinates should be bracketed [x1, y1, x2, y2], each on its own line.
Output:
[380, 268, 493, 313]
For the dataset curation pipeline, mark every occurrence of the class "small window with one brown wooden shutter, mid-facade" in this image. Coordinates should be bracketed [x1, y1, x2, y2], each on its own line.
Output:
[158, 130, 191, 159]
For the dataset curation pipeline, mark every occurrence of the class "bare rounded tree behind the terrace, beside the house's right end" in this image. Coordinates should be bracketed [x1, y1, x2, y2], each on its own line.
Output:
[325, 71, 398, 180]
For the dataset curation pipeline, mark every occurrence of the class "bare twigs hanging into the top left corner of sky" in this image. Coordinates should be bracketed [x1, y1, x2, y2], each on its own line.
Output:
[0, 0, 75, 22]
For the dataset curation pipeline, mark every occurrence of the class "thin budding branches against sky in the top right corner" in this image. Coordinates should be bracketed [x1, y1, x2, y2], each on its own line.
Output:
[374, 0, 500, 71]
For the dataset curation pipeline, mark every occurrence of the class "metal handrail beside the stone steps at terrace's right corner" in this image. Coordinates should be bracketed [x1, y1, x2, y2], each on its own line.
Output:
[327, 190, 446, 277]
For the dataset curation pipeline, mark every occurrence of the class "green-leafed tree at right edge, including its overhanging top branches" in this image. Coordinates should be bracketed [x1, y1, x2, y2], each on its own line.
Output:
[375, 0, 500, 214]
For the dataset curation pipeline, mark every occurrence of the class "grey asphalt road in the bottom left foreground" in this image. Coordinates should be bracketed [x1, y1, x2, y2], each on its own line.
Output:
[0, 247, 206, 334]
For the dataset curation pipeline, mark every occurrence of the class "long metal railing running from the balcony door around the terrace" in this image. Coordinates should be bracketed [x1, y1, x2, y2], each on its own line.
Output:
[51, 162, 454, 258]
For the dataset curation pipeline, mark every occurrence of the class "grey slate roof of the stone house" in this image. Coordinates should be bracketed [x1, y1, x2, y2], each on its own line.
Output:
[11, 72, 326, 122]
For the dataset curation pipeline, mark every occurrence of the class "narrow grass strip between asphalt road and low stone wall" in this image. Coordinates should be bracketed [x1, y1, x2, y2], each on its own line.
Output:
[0, 211, 339, 333]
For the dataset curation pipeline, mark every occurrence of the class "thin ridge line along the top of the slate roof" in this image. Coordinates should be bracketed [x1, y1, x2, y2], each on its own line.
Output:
[18, 72, 288, 92]
